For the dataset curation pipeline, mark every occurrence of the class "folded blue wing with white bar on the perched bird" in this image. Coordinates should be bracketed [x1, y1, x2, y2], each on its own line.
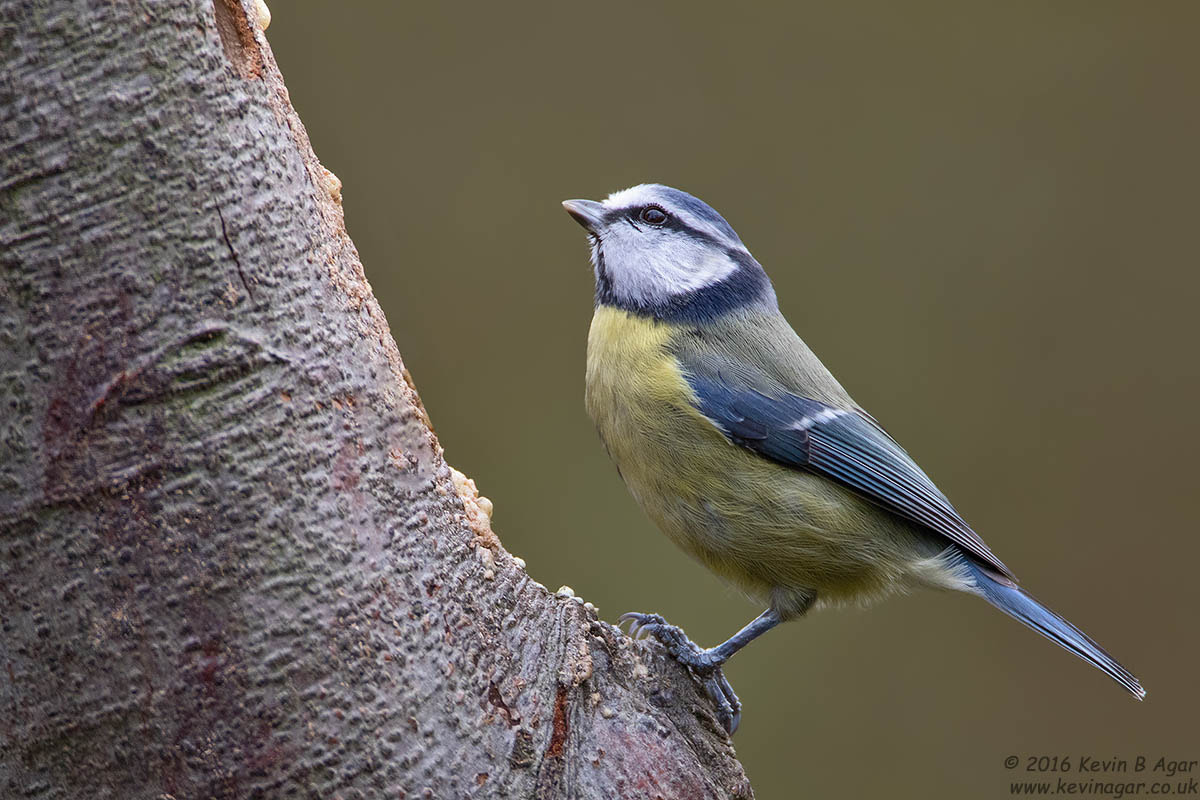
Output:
[685, 372, 1014, 578]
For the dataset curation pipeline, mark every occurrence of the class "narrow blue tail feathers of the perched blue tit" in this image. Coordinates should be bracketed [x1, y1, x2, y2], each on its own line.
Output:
[962, 558, 1146, 700]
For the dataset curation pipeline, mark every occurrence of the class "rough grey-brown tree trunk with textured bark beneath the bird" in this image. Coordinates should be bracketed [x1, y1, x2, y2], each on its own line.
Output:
[0, 0, 750, 799]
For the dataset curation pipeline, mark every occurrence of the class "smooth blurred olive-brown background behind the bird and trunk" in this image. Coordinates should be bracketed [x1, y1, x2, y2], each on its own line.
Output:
[268, 0, 1200, 799]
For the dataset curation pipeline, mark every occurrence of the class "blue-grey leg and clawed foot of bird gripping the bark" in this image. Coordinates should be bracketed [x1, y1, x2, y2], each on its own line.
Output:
[620, 608, 782, 734]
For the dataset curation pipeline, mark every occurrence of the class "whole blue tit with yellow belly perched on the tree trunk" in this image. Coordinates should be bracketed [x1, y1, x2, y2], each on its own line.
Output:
[563, 185, 1145, 733]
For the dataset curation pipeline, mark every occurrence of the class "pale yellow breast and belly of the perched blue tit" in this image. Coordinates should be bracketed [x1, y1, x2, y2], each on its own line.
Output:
[587, 306, 930, 607]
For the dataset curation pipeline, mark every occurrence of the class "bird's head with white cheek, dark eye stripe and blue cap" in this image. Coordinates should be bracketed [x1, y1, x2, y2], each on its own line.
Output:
[563, 184, 776, 321]
